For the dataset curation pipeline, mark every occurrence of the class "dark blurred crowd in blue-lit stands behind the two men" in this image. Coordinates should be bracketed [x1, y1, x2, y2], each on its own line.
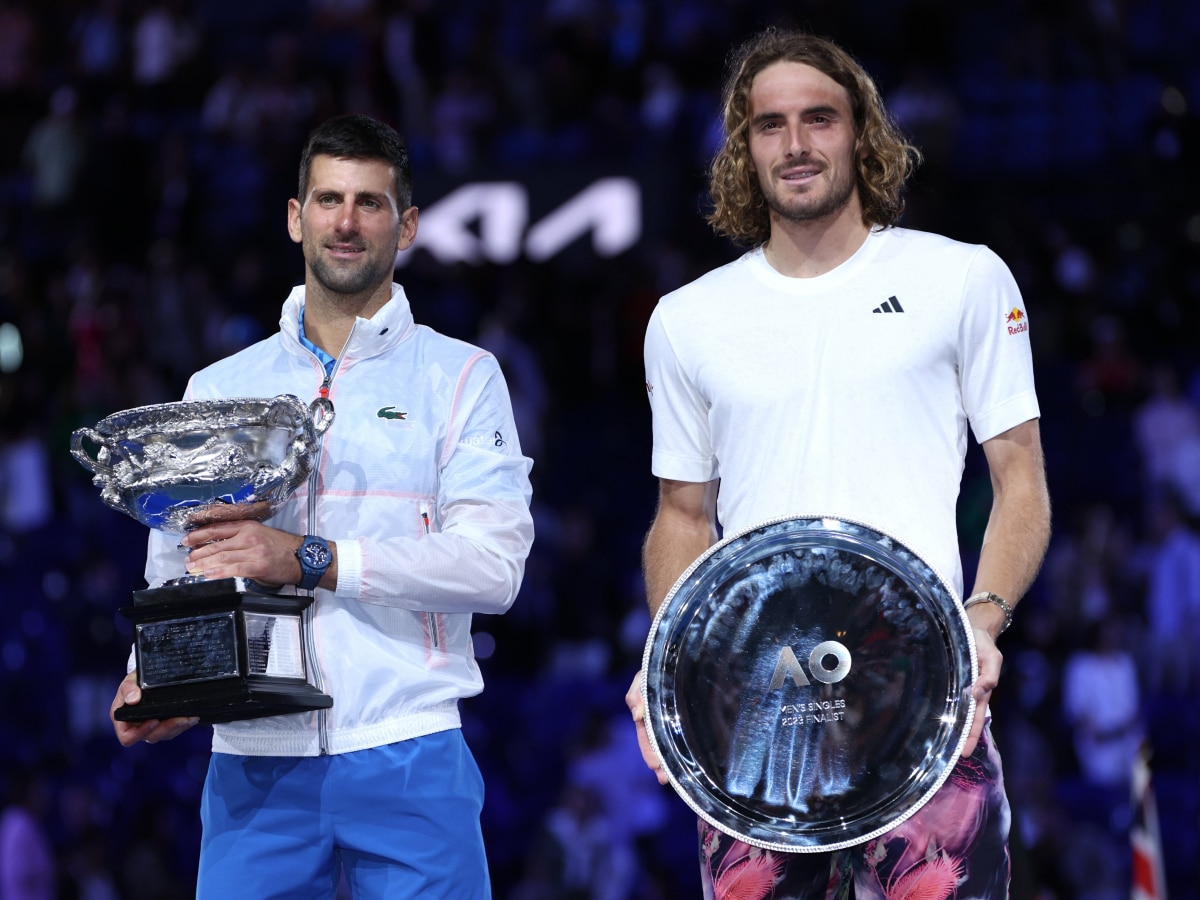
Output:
[0, 0, 1200, 900]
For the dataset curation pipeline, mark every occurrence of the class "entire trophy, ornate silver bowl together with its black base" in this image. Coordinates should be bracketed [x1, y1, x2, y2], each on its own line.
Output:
[71, 395, 334, 722]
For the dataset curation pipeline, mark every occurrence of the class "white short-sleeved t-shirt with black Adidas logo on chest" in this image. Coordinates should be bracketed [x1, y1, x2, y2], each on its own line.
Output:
[646, 228, 1038, 595]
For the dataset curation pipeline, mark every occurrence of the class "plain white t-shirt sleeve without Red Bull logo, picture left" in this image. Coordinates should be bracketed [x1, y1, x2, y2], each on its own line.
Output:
[644, 305, 720, 484]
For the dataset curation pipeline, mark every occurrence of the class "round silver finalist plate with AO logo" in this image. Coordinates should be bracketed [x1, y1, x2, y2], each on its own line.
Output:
[642, 516, 976, 852]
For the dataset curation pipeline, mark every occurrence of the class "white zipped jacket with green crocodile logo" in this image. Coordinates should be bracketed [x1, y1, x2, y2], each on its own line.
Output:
[146, 284, 533, 756]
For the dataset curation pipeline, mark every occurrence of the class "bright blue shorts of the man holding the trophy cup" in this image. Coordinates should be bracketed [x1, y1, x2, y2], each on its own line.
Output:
[196, 728, 491, 900]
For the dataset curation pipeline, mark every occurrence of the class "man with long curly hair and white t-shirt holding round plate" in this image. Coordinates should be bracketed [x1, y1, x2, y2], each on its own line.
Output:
[626, 29, 1050, 900]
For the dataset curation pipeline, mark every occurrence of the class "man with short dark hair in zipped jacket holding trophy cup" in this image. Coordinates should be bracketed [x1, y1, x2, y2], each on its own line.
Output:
[113, 115, 533, 900]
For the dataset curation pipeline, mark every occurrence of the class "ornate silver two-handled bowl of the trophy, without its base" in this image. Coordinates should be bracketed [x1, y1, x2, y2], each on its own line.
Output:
[71, 394, 334, 532]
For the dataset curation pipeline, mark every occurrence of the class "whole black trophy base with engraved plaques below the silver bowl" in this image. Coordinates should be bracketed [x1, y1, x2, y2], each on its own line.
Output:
[113, 578, 334, 724]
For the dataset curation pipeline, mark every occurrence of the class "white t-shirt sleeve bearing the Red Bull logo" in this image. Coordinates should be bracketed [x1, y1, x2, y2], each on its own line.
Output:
[958, 247, 1039, 443]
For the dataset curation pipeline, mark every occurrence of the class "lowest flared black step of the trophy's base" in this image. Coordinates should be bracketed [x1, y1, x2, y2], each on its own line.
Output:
[113, 678, 334, 725]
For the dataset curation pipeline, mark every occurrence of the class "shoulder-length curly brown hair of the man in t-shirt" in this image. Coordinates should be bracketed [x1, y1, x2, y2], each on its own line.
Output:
[707, 28, 920, 246]
